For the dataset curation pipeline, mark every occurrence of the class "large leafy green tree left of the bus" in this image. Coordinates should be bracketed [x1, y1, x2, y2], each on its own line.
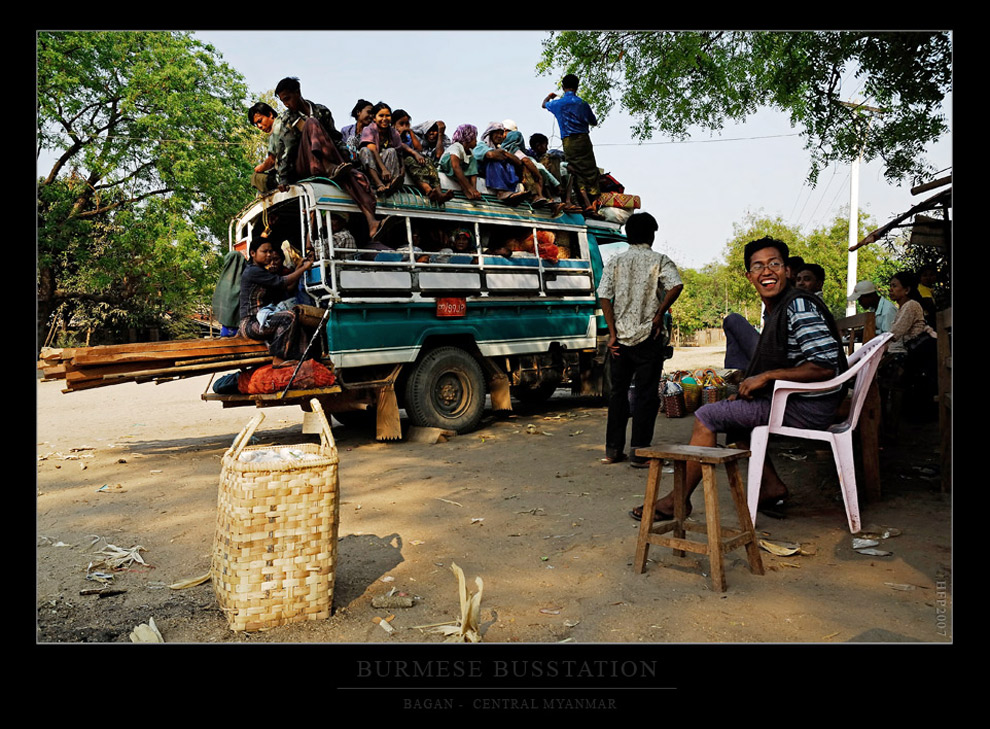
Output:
[37, 32, 252, 350]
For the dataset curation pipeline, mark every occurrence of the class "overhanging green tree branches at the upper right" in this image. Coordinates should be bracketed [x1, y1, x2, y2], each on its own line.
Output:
[537, 31, 952, 183]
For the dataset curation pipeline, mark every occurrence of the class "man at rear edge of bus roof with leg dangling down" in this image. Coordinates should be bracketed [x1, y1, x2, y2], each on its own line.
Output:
[275, 77, 380, 238]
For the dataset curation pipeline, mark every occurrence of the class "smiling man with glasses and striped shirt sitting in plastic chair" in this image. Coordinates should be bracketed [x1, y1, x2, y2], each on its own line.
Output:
[630, 238, 848, 521]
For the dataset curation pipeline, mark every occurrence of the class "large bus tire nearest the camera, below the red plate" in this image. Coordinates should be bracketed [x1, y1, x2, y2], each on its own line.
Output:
[405, 347, 485, 433]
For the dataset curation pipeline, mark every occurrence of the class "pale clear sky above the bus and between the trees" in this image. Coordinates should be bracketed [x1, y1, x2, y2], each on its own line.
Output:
[202, 31, 952, 268]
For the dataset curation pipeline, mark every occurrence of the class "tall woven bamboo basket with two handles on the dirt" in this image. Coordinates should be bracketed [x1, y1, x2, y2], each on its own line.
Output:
[211, 399, 340, 631]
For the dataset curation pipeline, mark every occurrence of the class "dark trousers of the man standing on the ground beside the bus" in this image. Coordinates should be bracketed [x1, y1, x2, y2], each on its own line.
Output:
[605, 337, 664, 458]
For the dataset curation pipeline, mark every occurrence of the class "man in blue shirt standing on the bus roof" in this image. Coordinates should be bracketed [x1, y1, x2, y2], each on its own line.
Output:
[543, 73, 601, 217]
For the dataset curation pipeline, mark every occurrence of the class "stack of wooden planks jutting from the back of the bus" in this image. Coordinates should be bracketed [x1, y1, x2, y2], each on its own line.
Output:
[38, 337, 272, 392]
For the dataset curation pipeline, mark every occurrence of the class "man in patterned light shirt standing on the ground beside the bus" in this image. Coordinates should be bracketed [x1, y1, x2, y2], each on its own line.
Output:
[598, 213, 684, 468]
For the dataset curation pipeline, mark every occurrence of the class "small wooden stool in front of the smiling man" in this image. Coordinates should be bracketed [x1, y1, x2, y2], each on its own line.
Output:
[634, 446, 763, 592]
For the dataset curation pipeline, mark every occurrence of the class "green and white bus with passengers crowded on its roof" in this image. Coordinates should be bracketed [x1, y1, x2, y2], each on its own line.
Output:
[213, 178, 626, 438]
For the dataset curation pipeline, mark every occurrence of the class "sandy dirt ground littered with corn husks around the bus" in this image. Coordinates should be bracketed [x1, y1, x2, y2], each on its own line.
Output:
[36, 348, 952, 645]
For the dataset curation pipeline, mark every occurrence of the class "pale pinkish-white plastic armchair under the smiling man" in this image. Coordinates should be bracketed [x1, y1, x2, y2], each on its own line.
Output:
[746, 332, 894, 534]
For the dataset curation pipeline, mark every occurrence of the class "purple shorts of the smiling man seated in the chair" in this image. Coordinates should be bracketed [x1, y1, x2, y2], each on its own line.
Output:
[694, 395, 842, 433]
